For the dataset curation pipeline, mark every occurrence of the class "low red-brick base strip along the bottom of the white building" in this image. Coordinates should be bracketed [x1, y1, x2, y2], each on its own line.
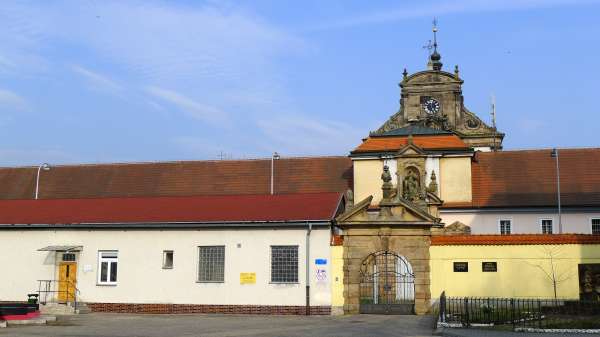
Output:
[86, 303, 331, 315]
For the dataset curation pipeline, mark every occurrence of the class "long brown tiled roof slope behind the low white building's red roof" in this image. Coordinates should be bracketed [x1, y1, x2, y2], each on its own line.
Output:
[0, 157, 352, 199]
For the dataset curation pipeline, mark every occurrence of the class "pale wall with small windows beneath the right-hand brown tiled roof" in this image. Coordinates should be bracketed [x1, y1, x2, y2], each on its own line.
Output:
[440, 210, 600, 234]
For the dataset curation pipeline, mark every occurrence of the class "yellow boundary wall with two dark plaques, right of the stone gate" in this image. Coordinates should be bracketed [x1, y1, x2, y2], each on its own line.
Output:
[430, 245, 600, 298]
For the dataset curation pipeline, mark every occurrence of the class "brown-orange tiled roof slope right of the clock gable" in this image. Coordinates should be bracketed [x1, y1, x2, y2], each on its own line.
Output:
[468, 148, 600, 207]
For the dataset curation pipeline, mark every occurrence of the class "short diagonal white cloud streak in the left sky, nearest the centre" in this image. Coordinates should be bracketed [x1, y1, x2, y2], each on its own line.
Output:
[146, 87, 228, 124]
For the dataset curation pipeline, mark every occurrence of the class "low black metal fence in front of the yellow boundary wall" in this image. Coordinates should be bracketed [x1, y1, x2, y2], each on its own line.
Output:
[438, 293, 600, 330]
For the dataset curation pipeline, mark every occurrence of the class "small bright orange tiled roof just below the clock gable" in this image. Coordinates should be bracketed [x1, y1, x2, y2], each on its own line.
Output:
[352, 134, 469, 153]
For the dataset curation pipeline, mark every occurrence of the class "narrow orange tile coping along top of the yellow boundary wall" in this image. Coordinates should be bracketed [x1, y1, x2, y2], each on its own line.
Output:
[431, 234, 600, 246]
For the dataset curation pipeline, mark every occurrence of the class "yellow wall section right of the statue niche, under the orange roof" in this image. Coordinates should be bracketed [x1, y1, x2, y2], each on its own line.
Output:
[439, 157, 471, 202]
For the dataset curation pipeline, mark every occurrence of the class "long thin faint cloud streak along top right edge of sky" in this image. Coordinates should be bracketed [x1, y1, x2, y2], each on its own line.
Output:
[308, 0, 600, 31]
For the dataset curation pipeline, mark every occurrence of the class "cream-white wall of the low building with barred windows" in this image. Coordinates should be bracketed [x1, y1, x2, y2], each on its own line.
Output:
[0, 228, 331, 305]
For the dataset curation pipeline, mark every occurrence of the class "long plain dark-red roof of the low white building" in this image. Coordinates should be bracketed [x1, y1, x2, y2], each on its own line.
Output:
[0, 193, 341, 226]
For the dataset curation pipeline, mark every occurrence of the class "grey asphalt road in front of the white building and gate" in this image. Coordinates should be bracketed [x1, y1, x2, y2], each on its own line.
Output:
[0, 313, 433, 337]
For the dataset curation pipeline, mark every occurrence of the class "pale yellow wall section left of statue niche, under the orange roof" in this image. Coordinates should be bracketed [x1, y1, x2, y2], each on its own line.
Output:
[353, 159, 383, 204]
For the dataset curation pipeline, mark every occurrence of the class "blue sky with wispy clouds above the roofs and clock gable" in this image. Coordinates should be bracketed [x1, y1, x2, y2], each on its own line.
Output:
[0, 0, 600, 166]
